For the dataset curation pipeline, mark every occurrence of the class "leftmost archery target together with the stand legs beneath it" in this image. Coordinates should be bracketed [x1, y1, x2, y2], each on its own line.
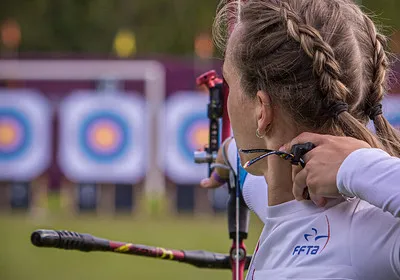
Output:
[0, 89, 52, 211]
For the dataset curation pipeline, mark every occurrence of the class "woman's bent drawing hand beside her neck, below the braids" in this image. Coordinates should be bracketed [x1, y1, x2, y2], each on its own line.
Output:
[280, 132, 371, 206]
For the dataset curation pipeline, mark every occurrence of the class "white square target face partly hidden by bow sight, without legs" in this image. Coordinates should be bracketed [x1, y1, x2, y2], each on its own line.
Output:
[159, 92, 209, 184]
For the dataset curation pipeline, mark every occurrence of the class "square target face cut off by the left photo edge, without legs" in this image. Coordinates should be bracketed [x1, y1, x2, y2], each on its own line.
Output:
[0, 89, 52, 181]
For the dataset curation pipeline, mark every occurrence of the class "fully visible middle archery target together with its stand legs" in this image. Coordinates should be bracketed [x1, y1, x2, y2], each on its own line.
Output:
[58, 90, 146, 215]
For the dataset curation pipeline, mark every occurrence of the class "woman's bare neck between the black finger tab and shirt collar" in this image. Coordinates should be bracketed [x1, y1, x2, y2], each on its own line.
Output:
[264, 156, 294, 206]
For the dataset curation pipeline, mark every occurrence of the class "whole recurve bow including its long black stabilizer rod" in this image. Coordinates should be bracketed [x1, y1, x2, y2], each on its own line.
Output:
[31, 0, 251, 280]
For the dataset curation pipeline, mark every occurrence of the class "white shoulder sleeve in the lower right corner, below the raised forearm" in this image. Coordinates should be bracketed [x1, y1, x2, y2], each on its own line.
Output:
[349, 201, 400, 280]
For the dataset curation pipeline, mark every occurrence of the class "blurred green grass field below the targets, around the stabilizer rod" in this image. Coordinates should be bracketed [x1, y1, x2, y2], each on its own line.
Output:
[0, 211, 261, 280]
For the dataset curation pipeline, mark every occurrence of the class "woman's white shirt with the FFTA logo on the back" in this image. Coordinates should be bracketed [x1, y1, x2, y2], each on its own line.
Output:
[229, 141, 400, 280]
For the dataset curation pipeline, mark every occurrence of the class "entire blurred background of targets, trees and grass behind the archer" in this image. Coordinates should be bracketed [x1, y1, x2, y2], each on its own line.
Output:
[0, 0, 400, 280]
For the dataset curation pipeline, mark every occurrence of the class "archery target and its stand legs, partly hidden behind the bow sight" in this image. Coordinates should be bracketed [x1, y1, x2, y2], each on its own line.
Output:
[159, 91, 228, 214]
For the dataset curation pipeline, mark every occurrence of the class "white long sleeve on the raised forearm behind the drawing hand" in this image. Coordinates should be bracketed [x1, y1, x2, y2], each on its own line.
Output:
[336, 149, 400, 217]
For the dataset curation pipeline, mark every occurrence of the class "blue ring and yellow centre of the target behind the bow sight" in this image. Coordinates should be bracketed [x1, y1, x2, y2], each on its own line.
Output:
[178, 113, 209, 162]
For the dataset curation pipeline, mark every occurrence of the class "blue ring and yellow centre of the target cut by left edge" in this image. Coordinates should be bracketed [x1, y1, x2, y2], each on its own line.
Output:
[0, 108, 32, 161]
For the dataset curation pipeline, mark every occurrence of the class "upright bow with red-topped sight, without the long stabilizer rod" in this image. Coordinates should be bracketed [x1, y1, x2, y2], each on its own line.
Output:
[195, 0, 249, 280]
